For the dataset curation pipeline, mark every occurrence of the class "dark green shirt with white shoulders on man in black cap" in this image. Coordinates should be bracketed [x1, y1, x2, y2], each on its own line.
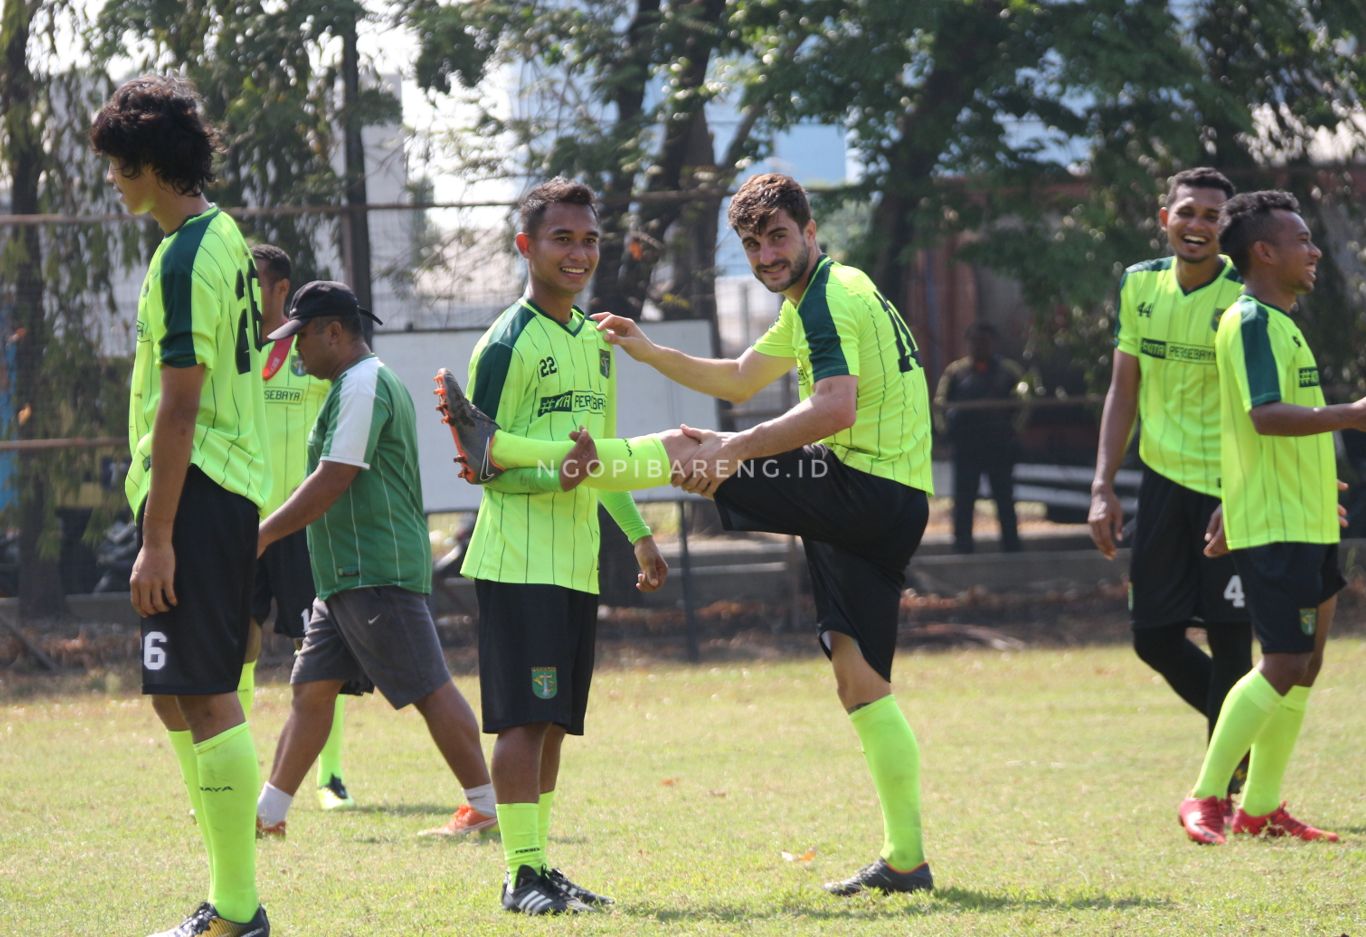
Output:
[309, 355, 432, 598]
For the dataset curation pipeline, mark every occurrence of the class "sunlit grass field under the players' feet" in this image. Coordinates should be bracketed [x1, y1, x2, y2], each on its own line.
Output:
[0, 637, 1366, 937]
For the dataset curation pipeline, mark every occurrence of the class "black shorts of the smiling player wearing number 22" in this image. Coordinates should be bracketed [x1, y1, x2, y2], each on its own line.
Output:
[474, 579, 598, 735]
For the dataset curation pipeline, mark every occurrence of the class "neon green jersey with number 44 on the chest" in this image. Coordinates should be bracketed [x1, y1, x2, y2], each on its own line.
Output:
[1115, 257, 1243, 497]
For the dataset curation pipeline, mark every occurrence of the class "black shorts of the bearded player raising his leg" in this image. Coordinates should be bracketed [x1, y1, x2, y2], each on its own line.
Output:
[716, 444, 929, 680]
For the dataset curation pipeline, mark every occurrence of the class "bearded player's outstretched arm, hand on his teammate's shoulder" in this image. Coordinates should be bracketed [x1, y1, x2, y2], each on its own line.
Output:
[591, 313, 792, 404]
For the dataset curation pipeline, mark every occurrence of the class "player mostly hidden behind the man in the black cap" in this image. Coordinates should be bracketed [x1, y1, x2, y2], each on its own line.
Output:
[238, 244, 355, 810]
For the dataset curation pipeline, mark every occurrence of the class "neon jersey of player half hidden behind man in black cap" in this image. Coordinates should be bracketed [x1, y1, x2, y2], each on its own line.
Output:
[261, 336, 331, 516]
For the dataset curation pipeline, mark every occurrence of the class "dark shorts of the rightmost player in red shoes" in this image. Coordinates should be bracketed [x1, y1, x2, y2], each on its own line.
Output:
[1232, 544, 1347, 654]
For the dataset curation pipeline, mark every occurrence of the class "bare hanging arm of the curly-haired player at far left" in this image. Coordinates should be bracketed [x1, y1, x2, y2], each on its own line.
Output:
[128, 365, 204, 617]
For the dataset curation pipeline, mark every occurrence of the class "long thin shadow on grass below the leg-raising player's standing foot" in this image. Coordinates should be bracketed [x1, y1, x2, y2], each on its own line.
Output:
[620, 888, 1173, 923]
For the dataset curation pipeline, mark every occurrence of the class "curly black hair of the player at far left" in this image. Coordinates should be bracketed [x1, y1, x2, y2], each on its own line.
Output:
[90, 75, 221, 195]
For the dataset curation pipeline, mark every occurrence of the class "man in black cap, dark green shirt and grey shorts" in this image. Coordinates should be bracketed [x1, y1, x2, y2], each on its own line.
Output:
[257, 280, 493, 836]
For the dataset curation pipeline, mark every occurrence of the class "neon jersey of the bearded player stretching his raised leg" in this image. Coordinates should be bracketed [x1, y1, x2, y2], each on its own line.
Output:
[754, 257, 934, 494]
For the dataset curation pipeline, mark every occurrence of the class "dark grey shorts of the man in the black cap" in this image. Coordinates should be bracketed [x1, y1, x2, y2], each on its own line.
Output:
[290, 586, 451, 709]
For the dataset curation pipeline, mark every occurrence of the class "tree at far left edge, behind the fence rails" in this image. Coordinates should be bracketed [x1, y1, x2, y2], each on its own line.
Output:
[0, 0, 126, 617]
